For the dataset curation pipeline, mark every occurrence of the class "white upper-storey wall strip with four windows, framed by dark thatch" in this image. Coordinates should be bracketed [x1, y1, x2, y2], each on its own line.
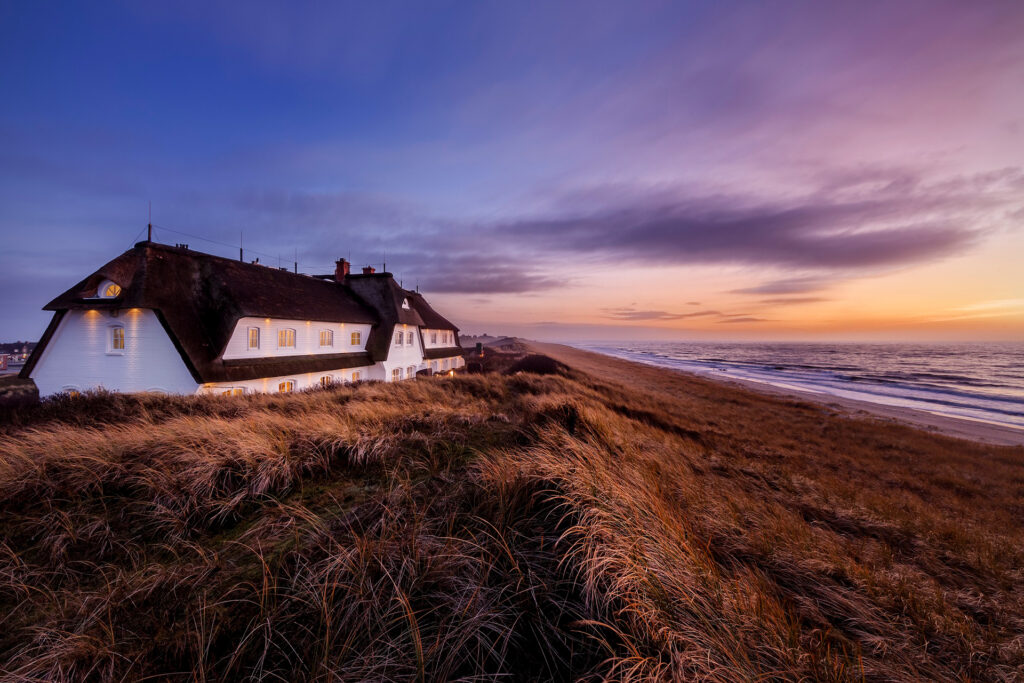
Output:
[223, 317, 372, 360]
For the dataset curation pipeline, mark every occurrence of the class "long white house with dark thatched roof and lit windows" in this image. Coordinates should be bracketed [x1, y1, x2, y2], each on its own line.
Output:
[22, 242, 463, 396]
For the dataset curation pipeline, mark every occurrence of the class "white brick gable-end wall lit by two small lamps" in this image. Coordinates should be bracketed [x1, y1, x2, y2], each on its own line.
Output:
[32, 308, 198, 396]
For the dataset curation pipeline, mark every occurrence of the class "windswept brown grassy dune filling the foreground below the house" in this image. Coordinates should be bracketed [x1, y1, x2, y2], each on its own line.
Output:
[0, 361, 1024, 681]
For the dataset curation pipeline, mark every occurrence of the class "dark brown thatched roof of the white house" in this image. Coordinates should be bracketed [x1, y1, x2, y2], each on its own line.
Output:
[25, 242, 457, 382]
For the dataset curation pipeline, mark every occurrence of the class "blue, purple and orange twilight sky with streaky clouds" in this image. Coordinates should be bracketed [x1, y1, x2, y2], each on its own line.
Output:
[0, 0, 1024, 341]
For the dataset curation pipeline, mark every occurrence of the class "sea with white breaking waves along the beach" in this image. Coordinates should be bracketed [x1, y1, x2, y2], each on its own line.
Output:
[573, 342, 1024, 430]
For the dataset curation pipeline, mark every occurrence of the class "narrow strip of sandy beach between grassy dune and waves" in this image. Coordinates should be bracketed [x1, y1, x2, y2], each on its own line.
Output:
[524, 341, 1024, 445]
